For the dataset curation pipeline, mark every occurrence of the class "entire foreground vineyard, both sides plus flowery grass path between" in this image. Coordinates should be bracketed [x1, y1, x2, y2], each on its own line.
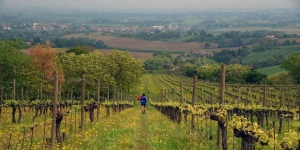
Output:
[0, 72, 300, 150]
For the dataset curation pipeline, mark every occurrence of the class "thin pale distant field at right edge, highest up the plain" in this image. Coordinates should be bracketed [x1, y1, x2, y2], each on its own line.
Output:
[207, 26, 300, 34]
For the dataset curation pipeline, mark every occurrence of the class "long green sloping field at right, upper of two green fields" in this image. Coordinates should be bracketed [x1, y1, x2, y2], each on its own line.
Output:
[243, 45, 300, 63]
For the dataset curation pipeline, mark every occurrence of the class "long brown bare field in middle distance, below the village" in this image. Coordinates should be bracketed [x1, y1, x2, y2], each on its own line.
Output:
[63, 32, 218, 53]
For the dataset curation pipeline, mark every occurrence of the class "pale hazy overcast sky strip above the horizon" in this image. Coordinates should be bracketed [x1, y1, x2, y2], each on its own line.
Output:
[0, 0, 300, 10]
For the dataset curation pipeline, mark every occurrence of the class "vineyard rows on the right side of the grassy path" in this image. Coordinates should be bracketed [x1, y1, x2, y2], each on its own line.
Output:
[147, 71, 300, 150]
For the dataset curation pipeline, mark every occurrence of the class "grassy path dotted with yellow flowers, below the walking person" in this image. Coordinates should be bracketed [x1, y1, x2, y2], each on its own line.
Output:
[62, 103, 218, 150]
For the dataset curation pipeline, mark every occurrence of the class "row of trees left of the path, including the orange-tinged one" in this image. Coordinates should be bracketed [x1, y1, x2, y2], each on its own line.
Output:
[0, 40, 145, 100]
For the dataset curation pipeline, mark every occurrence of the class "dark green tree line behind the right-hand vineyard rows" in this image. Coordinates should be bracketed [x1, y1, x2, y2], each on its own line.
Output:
[144, 50, 300, 84]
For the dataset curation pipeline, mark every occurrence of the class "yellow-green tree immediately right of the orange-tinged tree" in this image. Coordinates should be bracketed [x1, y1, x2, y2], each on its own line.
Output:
[57, 51, 109, 99]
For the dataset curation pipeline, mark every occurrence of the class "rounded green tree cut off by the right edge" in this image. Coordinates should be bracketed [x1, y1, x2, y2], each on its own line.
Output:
[280, 53, 300, 83]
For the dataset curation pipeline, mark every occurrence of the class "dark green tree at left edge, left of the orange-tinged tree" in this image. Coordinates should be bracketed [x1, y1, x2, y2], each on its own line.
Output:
[0, 40, 38, 99]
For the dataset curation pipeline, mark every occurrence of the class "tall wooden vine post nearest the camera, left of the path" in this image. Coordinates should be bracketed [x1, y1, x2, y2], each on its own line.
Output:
[50, 71, 58, 150]
